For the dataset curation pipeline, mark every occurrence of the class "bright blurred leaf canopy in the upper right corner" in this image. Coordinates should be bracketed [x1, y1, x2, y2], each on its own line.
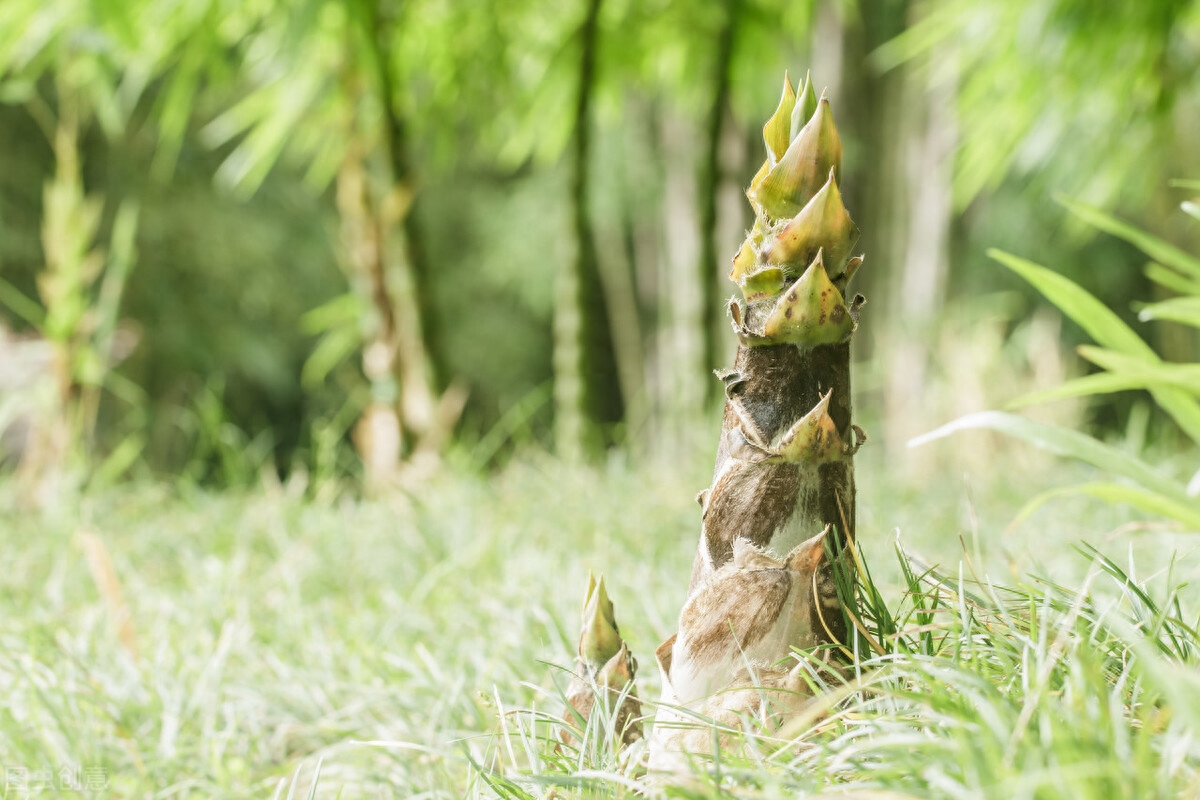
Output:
[875, 0, 1200, 207]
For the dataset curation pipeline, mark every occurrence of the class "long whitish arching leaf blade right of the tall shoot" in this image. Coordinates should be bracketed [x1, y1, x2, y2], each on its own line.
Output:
[908, 411, 1187, 500]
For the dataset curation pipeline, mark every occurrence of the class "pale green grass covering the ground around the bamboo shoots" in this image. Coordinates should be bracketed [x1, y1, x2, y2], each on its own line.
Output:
[0, 441, 1200, 798]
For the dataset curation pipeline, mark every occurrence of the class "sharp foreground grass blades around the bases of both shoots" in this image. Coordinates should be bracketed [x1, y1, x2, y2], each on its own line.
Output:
[470, 522, 1200, 800]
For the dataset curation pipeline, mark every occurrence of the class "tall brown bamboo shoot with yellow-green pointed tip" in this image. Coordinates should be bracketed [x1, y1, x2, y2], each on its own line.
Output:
[649, 77, 865, 770]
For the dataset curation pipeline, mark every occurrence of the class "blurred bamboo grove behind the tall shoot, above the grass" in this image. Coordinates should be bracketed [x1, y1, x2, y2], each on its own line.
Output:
[0, 0, 1200, 500]
